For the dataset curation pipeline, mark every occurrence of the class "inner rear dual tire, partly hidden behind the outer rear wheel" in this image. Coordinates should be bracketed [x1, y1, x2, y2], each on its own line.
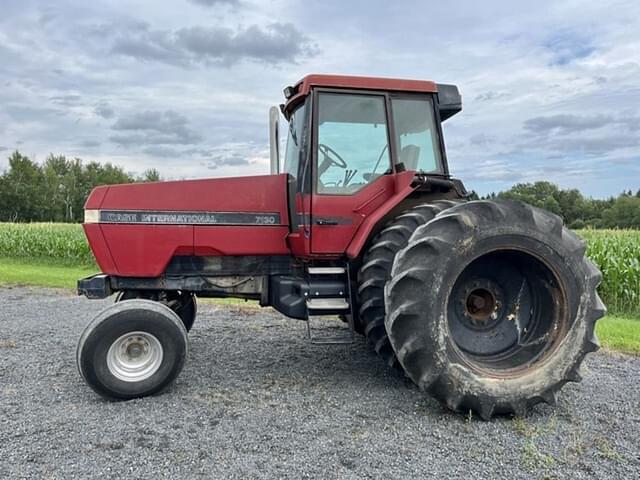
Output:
[358, 200, 456, 366]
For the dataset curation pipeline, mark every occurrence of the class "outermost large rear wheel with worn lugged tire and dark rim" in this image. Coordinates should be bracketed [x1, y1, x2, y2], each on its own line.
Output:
[385, 201, 605, 419]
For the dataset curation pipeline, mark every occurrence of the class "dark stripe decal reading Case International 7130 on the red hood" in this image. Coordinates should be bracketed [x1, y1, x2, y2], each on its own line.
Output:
[100, 210, 280, 225]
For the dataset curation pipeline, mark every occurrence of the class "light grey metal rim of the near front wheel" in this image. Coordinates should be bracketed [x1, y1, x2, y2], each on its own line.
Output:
[107, 331, 164, 382]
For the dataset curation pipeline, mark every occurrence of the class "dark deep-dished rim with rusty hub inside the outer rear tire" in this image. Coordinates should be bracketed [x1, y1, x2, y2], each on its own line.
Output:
[448, 250, 562, 375]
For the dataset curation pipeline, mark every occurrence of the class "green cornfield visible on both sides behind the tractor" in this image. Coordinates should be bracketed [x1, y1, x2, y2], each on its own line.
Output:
[0, 223, 640, 315]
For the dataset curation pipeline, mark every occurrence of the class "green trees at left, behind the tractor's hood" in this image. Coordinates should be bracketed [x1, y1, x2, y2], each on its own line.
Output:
[0, 151, 160, 223]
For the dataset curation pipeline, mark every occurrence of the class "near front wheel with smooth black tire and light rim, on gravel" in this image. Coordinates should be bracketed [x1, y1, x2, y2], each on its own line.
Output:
[76, 299, 188, 400]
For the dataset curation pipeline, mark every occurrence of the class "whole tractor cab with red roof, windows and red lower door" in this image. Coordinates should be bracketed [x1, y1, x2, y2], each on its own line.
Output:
[271, 75, 461, 256]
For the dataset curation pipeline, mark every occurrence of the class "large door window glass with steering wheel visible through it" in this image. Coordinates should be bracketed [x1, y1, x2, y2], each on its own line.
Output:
[316, 92, 391, 195]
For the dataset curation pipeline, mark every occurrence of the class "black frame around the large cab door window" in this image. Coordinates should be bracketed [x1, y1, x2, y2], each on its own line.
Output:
[311, 88, 397, 197]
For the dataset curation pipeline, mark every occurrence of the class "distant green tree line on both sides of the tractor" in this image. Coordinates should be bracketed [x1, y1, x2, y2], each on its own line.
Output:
[0, 151, 640, 229]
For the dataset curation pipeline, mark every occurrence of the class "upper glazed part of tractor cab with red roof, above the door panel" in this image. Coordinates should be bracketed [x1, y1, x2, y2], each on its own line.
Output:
[280, 75, 461, 187]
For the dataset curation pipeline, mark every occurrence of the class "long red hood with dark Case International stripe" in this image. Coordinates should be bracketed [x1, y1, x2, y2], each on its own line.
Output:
[84, 174, 289, 277]
